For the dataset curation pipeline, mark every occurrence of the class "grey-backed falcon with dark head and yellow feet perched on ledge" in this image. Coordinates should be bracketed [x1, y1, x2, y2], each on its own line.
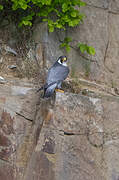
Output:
[37, 56, 69, 98]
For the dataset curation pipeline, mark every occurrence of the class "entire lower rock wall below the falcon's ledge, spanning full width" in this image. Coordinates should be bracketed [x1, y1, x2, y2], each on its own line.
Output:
[0, 85, 119, 180]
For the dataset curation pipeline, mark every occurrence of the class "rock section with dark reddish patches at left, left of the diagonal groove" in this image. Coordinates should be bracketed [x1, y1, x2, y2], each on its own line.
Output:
[0, 79, 34, 179]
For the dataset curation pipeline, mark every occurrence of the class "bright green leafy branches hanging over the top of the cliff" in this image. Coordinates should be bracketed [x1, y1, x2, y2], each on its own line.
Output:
[0, 0, 95, 55]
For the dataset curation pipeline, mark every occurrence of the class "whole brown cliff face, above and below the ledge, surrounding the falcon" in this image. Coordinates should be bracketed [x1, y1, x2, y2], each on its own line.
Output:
[0, 0, 119, 180]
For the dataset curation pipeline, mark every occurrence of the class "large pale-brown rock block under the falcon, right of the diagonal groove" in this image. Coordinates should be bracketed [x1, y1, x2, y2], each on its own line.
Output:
[20, 93, 119, 180]
